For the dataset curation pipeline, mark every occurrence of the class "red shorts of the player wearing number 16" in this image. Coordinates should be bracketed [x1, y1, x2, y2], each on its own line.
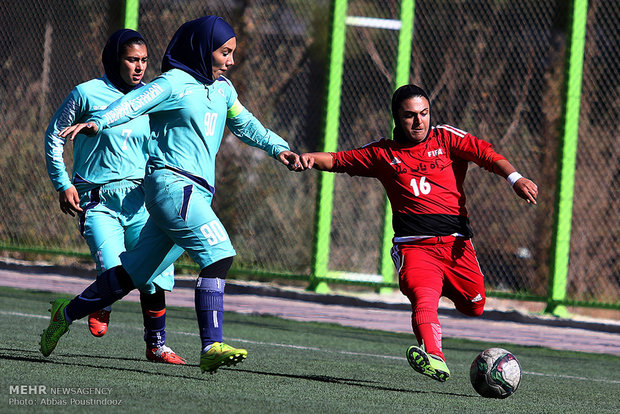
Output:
[392, 236, 486, 316]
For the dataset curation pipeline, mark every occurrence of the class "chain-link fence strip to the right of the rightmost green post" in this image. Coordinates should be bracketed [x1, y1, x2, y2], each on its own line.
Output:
[568, 0, 620, 303]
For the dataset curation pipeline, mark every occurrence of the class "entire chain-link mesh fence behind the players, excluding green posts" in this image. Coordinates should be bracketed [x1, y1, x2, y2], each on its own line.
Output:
[0, 0, 620, 307]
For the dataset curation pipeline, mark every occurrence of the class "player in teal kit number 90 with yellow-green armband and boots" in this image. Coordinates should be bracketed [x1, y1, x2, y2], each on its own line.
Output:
[41, 16, 300, 372]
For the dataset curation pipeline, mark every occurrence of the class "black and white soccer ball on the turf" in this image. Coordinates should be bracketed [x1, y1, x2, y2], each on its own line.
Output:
[469, 348, 521, 398]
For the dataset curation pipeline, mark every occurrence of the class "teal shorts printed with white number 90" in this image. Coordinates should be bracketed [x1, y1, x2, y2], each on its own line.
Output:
[121, 169, 236, 287]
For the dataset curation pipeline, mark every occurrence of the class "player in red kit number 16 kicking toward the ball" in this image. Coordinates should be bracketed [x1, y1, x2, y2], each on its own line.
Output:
[301, 85, 538, 382]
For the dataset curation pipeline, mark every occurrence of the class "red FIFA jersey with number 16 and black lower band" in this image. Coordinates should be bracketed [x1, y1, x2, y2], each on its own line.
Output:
[330, 125, 505, 239]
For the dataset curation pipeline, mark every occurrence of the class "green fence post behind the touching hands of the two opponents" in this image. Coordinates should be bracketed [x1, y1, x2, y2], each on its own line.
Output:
[307, 0, 347, 293]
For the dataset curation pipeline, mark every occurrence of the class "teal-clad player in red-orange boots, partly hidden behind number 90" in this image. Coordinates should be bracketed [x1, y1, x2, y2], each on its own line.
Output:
[45, 29, 185, 364]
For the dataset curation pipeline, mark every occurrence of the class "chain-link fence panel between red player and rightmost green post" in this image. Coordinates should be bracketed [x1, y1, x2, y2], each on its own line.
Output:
[412, 1, 565, 295]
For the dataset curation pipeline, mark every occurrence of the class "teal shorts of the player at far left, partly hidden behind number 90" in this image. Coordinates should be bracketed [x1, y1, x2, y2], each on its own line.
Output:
[79, 181, 174, 293]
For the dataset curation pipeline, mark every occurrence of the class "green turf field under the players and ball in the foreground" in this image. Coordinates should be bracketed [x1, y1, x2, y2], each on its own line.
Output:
[0, 288, 620, 414]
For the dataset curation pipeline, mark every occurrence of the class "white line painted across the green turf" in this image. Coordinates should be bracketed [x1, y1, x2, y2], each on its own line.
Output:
[6, 311, 620, 384]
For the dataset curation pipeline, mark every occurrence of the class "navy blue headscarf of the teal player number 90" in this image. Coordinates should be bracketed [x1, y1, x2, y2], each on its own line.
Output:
[161, 16, 235, 85]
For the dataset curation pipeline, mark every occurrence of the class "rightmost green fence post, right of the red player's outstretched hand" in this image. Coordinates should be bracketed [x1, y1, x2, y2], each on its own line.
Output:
[545, 0, 588, 316]
